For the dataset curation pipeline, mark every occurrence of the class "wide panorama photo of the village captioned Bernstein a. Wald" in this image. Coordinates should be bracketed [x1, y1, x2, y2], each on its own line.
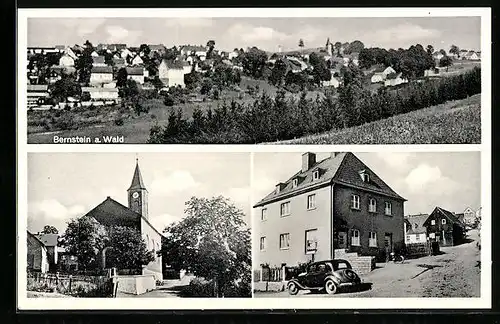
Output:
[19, 13, 489, 144]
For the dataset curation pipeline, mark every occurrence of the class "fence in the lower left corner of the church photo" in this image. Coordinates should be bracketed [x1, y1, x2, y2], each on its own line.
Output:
[27, 272, 114, 297]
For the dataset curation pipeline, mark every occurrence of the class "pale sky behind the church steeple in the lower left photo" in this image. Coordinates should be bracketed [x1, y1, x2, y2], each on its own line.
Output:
[27, 153, 250, 233]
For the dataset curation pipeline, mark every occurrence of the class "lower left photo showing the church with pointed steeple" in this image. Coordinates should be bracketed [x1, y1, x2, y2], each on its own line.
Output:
[26, 153, 251, 298]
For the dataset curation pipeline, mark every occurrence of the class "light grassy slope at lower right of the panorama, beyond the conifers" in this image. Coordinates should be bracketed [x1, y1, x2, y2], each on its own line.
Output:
[278, 94, 481, 144]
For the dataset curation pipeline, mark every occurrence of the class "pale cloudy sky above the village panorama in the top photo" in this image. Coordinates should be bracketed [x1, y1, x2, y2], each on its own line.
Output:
[27, 17, 481, 52]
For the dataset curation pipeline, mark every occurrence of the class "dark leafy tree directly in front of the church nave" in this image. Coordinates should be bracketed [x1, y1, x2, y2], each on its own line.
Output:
[106, 226, 156, 270]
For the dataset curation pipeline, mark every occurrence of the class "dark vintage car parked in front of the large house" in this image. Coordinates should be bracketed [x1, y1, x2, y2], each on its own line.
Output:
[287, 259, 361, 295]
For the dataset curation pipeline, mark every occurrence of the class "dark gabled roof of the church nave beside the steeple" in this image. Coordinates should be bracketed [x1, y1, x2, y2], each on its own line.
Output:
[84, 197, 162, 235]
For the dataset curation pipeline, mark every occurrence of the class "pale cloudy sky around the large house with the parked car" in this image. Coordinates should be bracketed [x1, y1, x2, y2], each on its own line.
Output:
[252, 152, 481, 215]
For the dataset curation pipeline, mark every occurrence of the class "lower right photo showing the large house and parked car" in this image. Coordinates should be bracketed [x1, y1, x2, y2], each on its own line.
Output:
[252, 151, 482, 298]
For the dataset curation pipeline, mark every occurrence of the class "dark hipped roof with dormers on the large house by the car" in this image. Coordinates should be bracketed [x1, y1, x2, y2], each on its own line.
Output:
[254, 152, 405, 207]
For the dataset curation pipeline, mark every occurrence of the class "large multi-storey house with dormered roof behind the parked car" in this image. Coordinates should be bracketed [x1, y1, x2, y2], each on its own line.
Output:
[253, 152, 406, 266]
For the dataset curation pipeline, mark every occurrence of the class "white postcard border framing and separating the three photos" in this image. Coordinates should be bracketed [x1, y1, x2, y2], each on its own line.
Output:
[16, 8, 491, 310]
